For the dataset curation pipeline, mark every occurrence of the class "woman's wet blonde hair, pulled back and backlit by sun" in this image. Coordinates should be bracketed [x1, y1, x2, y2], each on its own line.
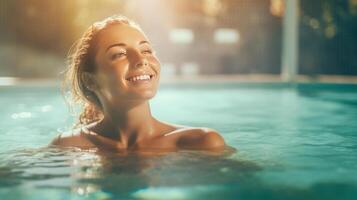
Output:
[62, 15, 143, 127]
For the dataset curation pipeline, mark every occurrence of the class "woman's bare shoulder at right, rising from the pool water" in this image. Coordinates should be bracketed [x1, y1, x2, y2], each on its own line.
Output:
[165, 127, 225, 149]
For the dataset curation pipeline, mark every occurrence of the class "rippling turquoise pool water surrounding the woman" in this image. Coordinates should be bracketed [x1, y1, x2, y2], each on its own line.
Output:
[0, 83, 357, 200]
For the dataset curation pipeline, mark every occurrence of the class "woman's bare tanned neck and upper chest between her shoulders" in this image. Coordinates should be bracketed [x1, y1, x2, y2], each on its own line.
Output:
[97, 101, 155, 148]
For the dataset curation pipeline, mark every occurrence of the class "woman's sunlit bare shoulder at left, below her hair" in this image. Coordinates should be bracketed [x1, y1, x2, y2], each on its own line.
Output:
[50, 128, 94, 148]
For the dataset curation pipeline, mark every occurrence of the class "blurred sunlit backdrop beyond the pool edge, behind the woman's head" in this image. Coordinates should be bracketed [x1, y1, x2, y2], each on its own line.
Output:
[0, 0, 357, 84]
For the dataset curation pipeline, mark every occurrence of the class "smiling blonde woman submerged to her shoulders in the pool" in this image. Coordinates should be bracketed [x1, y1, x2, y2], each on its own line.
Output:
[51, 16, 225, 151]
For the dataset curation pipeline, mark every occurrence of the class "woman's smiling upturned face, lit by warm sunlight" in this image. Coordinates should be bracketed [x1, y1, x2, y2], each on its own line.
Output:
[95, 24, 160, 101]
